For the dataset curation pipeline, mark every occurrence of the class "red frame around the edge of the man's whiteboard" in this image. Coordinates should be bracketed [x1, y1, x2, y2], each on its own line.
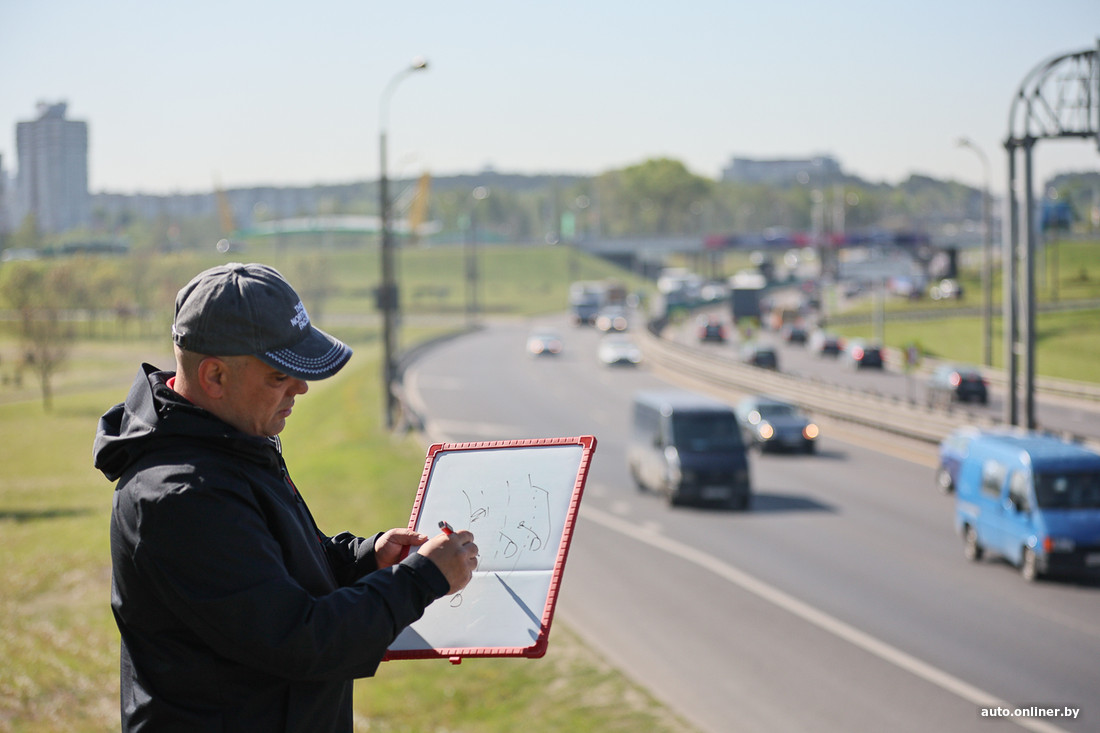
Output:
[383, 435, 596, 664]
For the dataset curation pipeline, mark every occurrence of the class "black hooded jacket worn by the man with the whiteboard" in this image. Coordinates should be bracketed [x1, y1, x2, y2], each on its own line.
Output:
[94, 364, 448, 733]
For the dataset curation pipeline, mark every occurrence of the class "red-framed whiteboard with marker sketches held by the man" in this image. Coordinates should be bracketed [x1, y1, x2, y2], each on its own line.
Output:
[385, 436, 596, 664]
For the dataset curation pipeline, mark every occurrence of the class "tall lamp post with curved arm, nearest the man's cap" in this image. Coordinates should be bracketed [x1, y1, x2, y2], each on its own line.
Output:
[377, 56, 428, 428]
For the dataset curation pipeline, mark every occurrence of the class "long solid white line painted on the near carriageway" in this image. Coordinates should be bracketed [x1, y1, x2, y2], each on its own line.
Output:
[581, 506, 1066, 733]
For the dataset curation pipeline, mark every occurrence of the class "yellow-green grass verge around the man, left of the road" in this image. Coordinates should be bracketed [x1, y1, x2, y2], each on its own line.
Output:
[0, 332, 688, 733]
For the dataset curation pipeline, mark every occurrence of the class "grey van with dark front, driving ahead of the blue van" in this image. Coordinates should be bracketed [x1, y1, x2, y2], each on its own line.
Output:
[627, 390, 752, 510]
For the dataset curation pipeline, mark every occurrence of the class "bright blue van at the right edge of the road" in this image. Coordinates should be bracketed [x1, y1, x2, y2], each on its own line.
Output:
[955, 430, 1100, 580]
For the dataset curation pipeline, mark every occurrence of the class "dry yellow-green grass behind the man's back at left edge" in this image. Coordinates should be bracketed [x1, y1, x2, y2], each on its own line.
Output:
[0, 390, 119, 731]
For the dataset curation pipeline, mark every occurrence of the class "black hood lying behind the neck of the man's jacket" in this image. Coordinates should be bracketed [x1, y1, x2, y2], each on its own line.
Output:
[92, 364, 278, 481]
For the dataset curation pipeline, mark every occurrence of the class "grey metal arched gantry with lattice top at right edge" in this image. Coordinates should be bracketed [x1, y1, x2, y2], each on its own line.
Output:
[1003, 41, 1100, 429]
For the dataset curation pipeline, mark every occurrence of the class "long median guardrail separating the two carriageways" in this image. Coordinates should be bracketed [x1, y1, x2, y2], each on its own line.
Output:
[639, 320, 1100, 449]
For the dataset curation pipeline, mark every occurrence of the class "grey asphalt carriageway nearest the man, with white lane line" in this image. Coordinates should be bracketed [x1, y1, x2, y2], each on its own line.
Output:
[405, 316, 1100, 733]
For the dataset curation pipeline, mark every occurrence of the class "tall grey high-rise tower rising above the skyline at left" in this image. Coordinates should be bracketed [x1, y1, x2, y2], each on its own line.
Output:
[14, 102, 90, 233]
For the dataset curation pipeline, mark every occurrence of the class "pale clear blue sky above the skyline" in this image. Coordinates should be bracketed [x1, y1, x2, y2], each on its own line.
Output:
[0, 0, 1100, 194]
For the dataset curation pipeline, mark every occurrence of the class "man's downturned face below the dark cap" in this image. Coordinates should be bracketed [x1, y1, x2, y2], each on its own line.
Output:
[219, 357, 309, 437]
